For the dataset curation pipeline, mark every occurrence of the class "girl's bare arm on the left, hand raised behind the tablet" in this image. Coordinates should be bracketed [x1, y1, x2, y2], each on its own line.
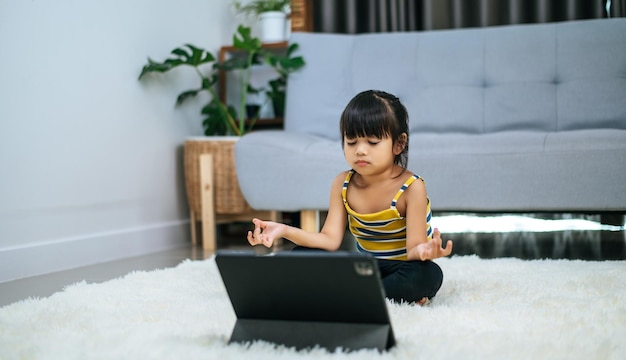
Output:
[248, 172, 347, 251]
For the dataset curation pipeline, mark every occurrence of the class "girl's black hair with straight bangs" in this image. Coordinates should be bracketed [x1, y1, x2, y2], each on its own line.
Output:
[339, 90, 409, 168]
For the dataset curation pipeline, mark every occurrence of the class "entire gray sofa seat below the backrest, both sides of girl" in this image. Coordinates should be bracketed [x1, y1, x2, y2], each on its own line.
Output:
[235, 129, 626, 211]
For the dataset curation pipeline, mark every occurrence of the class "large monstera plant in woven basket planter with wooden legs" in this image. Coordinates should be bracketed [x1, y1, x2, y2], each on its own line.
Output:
[139, 26, 267, 248]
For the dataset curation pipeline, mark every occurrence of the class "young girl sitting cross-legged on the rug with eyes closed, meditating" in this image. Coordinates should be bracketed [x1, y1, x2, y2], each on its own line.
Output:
[248, 90, 452, 305]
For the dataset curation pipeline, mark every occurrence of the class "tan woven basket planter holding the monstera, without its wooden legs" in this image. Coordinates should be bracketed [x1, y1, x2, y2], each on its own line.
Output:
[184, 137, 253, 219]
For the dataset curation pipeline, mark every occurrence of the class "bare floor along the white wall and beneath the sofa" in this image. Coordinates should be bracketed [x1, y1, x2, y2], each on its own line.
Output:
[0, 214, 626, 307]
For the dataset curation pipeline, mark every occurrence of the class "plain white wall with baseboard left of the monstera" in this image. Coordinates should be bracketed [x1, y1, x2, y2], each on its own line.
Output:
[0, 0, 254, 282]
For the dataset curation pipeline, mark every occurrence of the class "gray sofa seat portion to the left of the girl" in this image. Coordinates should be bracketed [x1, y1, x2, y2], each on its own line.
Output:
[235, 130, 347, 211]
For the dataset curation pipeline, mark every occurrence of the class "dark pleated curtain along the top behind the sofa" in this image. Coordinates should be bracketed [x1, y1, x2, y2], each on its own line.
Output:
[312, 0, 626, 34]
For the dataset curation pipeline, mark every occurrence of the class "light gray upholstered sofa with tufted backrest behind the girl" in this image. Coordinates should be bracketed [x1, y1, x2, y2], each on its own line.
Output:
[235, 18, 626, 225]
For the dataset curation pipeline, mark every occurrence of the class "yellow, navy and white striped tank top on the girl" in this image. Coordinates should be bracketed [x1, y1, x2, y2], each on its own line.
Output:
[341, 170, 433, 260]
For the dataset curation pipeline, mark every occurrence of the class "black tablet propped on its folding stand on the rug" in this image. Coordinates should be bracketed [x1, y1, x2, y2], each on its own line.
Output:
[215, 250, 395, 350]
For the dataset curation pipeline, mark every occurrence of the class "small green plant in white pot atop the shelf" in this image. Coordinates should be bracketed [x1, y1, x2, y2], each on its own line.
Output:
[234, 0, 291, 43]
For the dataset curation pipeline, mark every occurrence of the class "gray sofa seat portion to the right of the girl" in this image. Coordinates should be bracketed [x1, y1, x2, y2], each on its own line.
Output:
[409, 129, 626, 211]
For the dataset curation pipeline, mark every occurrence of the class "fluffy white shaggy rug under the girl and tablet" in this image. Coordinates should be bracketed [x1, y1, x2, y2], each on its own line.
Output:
[0, 256, 626, 360]
